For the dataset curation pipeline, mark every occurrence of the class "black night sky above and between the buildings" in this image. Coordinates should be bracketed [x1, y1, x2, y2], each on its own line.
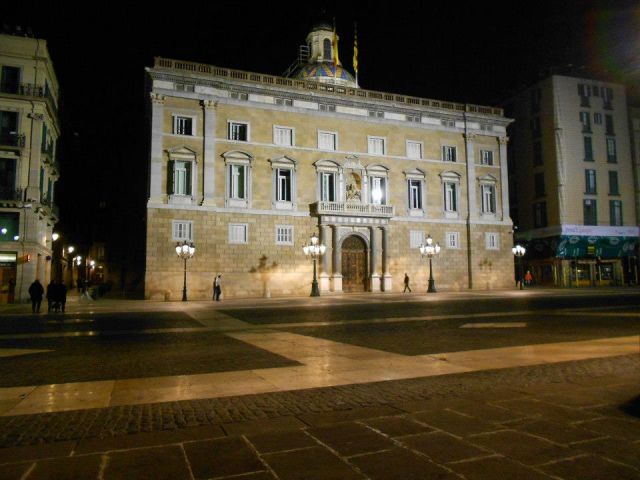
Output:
[0, 0, 640, 284]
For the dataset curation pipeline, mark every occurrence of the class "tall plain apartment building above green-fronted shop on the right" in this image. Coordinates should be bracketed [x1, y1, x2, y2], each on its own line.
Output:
[507, 75, 638, 286]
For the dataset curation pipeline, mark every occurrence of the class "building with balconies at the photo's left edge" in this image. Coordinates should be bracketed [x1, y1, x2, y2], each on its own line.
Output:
[0, 30, 60, 303]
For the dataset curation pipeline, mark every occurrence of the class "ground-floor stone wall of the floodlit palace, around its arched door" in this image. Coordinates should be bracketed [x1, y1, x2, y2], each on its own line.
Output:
[145, 208, 514, 300]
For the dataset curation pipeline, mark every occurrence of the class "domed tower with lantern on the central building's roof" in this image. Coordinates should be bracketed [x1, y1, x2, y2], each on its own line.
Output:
[293, 21, 357, 87]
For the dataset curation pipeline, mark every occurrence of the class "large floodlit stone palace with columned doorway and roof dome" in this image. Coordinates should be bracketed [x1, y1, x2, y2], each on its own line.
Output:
[146, 23, 514, 299]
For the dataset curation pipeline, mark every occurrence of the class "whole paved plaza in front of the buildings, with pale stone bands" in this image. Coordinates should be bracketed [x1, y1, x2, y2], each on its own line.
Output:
[0, 289, 640, 479]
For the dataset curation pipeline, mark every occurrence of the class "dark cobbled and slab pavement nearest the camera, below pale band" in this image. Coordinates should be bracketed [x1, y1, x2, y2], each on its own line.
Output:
[0, 355, 640, 480]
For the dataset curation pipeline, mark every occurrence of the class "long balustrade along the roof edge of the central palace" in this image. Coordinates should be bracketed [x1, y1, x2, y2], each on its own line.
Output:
[155, 57, 504, 116]
